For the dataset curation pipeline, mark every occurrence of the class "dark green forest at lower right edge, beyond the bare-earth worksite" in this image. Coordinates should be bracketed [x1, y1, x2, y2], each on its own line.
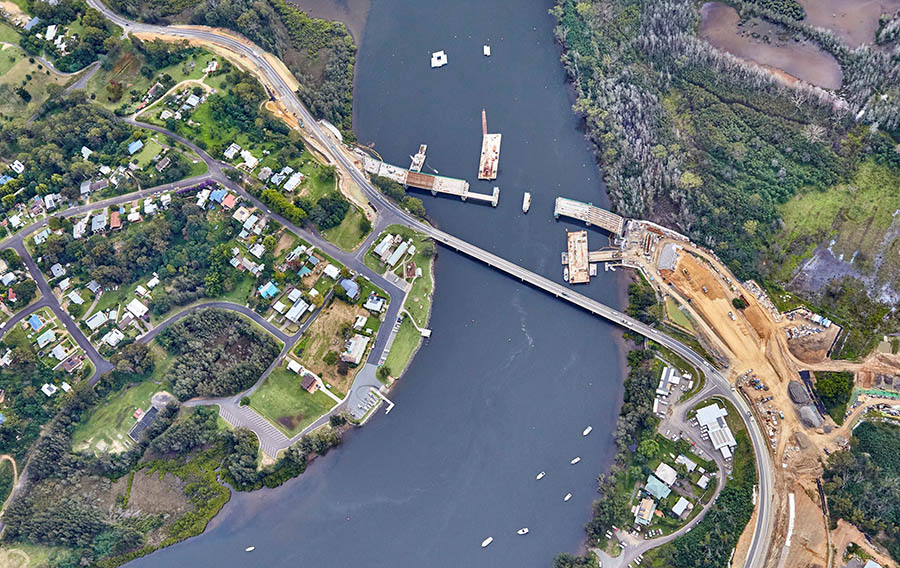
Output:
[823, 422, 900, 558]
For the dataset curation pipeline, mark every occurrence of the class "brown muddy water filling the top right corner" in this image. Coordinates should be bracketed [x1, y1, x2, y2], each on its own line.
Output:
[800, 0, 900, 47]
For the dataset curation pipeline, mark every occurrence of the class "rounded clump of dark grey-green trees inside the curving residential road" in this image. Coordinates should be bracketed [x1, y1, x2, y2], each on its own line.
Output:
[158, 310, 280, 400]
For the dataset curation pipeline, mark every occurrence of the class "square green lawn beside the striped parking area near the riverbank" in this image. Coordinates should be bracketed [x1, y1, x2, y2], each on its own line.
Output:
[250, 364, 336, 436]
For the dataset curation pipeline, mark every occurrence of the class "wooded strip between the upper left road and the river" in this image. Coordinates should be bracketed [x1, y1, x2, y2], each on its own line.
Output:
[110, 0, 356, 134]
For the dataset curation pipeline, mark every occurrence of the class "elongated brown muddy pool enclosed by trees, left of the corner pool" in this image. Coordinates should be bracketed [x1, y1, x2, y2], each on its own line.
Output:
[700, 2, 843, 89]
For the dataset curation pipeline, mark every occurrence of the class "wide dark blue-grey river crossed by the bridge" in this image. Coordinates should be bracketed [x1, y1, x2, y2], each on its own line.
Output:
[130, 0, 623, 568]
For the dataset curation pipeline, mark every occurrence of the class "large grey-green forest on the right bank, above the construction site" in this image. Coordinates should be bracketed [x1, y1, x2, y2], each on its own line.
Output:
[551, 0, 900, 356]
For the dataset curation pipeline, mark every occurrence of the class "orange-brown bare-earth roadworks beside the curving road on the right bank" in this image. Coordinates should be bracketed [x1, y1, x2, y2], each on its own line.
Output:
[642, 239, 900, 568]
